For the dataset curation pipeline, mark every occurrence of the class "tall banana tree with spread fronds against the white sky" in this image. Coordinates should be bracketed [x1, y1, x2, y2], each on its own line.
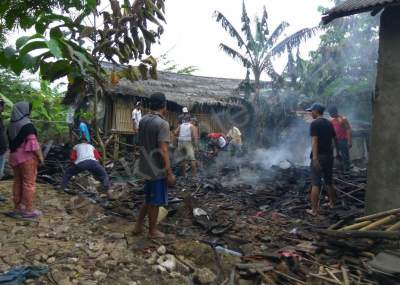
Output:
[215, 1, 316, 103]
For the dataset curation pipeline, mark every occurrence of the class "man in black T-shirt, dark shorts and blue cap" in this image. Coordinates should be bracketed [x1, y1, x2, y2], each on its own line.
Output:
[307, 103, 338, 216]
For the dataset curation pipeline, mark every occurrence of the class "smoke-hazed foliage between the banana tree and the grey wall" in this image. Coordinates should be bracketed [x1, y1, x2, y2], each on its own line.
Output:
[286, 1, 379, 119]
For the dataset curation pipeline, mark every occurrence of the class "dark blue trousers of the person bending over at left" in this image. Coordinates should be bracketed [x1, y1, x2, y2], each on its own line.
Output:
[61, 160, 110, 190]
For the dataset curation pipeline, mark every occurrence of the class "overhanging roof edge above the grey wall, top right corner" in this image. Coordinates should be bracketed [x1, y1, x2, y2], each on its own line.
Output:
[322, 0, 400, 24]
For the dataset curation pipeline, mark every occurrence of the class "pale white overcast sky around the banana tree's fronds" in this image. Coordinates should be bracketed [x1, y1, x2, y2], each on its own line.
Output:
[152, 0, 333, 78]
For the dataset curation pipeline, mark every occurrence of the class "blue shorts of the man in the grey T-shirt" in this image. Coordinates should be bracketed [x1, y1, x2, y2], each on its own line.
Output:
[144, 178, 168, 206]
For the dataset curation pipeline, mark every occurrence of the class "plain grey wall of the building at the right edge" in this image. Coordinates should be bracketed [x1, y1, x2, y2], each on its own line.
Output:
[366, 6, 400, 213]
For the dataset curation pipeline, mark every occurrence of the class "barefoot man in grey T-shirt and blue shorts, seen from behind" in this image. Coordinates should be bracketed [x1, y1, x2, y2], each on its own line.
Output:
[133, 93, 176, 238]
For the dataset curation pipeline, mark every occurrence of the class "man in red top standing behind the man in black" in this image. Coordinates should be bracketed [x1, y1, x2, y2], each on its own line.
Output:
[329, 106, 353, 172]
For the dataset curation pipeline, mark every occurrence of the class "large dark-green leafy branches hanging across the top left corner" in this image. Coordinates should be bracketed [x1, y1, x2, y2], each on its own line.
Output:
[0, 0, 165, 84]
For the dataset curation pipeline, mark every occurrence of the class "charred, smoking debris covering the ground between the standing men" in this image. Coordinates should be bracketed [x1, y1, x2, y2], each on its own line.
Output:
[10, 139, 392, 284]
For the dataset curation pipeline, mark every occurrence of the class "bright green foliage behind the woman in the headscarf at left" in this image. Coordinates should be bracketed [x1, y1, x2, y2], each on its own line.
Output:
[0, 70, 68, 140]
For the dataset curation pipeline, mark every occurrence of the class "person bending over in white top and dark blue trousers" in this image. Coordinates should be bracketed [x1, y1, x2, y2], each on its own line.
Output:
[60, 137, 110, 191]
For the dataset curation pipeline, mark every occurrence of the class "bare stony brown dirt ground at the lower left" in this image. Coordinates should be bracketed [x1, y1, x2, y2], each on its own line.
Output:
[0, 181, 190, 285]
